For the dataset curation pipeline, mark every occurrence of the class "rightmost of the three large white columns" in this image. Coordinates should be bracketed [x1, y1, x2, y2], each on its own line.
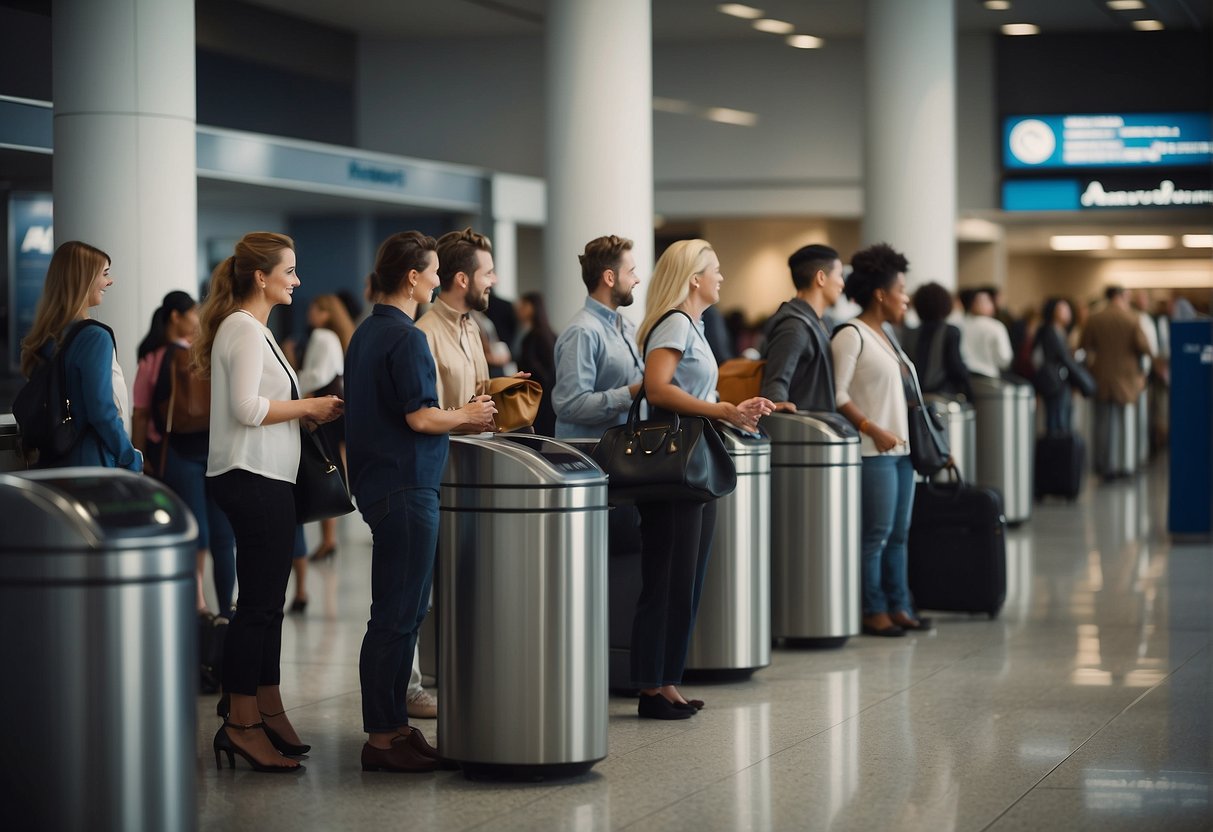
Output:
[864, 0, 956, 289]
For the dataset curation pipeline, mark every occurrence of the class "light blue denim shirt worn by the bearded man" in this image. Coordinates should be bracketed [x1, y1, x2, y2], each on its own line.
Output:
[552, 297, 644, 438]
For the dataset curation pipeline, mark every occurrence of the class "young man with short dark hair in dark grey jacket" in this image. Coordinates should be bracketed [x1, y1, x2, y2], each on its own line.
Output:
[762, 245, 843, 412]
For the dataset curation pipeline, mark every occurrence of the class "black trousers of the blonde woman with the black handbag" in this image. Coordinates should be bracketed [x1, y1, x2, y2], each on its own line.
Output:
[632, 500, 716, 688]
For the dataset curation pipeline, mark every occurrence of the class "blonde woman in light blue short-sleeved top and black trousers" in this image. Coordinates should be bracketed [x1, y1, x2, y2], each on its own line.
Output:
[632, 240, 775, 719]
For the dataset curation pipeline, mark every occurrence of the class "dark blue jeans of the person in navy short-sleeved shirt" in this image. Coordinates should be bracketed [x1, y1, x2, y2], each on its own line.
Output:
[358, 488, 438, 734]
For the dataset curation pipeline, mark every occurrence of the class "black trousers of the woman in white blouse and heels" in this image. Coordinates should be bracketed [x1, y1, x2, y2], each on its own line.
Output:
[213, 468, 295, 696]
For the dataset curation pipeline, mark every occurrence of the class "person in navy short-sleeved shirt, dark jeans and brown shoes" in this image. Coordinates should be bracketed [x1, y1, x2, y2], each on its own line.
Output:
[346, 232, 496, 773]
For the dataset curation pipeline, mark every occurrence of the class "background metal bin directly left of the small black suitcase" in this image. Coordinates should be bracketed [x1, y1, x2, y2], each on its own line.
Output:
[969, 376, 1036, 525]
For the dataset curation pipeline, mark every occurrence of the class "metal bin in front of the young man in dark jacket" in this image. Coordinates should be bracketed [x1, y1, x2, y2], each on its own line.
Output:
[763, 411, 862, 648]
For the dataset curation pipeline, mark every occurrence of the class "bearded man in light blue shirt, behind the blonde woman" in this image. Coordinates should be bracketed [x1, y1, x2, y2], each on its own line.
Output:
[552, 235, 644, 439]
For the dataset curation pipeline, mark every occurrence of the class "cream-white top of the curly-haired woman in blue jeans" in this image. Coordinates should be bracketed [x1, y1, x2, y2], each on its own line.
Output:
[830, 319, 910, 456]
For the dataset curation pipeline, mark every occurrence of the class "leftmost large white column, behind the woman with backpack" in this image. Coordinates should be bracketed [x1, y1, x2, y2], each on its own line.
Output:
[52, 0, 198, 375]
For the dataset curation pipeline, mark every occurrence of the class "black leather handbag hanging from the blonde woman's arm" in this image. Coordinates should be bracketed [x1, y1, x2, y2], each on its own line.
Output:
[593, 387, 738, 505]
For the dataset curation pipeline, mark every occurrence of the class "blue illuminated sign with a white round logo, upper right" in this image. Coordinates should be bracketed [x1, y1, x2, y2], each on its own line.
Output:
[1002, 113, 1213, 172]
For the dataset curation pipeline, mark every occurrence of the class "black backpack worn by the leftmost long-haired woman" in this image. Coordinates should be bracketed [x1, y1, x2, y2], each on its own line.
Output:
[12, 318, 118, 466]
